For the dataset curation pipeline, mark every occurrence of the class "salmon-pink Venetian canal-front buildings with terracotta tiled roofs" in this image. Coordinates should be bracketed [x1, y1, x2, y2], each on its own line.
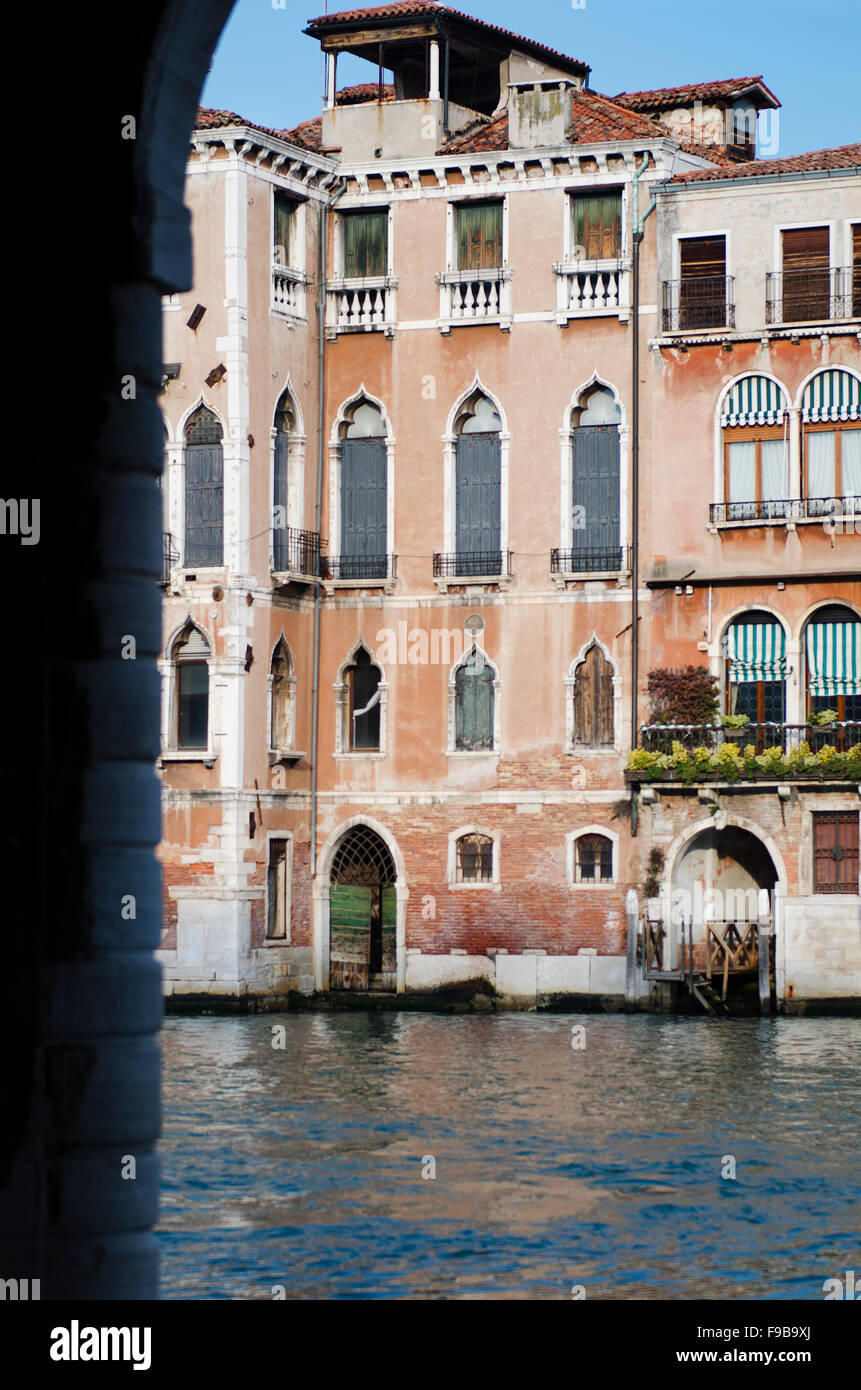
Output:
[160, 0, 861, 1008]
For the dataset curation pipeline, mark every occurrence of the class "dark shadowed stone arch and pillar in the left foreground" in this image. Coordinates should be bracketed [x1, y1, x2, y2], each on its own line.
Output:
[0, 0, 232, 1300]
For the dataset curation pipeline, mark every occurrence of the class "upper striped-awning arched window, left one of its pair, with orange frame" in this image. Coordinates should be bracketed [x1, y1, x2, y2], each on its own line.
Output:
[721, 377, 789, 521]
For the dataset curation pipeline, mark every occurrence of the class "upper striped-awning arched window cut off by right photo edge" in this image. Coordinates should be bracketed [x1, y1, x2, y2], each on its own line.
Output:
[801, 367, 861, 516]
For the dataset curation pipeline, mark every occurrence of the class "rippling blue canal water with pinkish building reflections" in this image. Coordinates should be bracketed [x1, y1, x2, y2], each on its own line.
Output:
[160, 1013, 861, 1298]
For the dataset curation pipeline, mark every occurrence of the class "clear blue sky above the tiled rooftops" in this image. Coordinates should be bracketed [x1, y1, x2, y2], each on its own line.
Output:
[202, 0, 861, 156]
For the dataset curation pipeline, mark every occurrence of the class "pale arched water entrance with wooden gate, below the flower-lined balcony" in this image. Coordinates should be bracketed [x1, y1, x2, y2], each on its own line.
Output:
[670, 826, 779, 995]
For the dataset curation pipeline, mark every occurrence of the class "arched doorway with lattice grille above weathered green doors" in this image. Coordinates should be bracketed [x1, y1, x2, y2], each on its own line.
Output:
[328, 826, 398, 991]
